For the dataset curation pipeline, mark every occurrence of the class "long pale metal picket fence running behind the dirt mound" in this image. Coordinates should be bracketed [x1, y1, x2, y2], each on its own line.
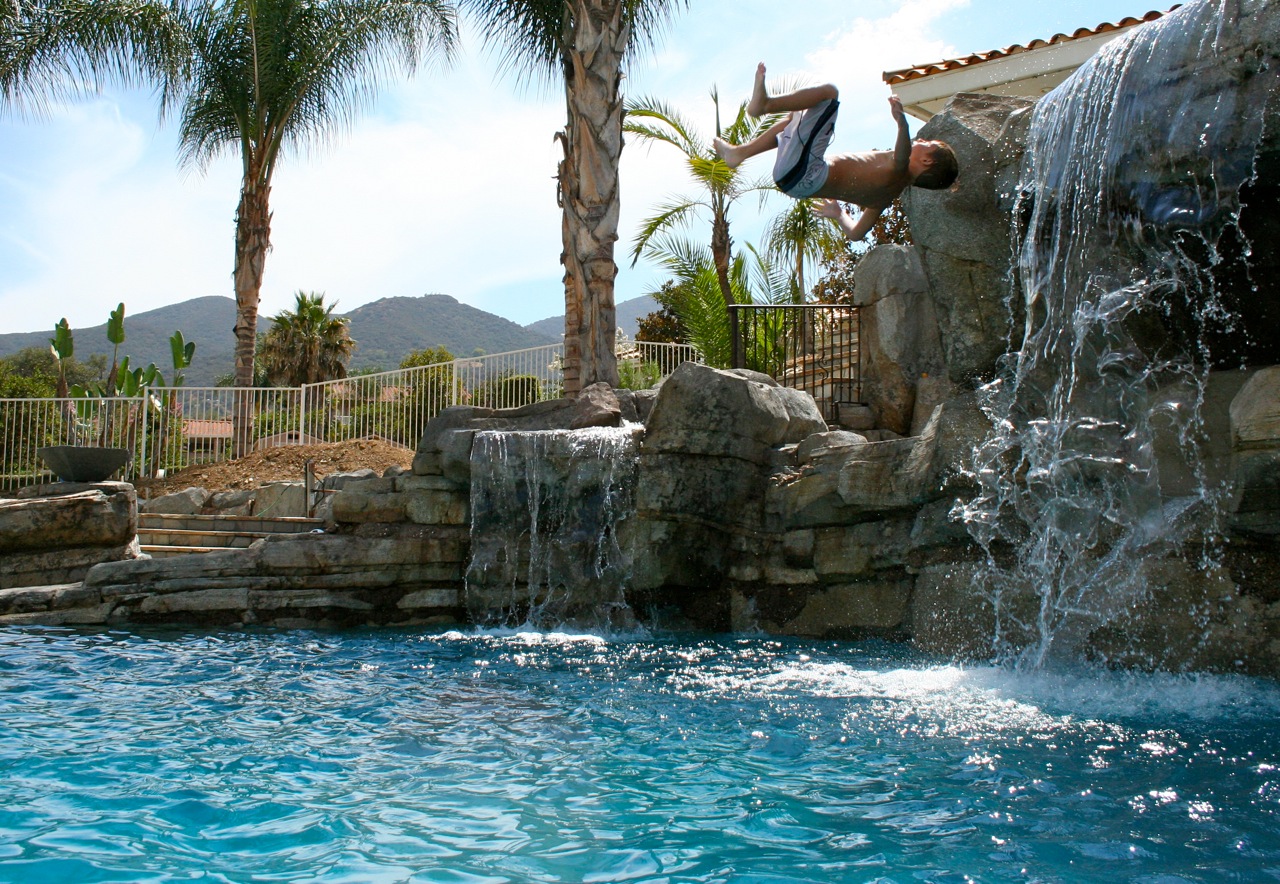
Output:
[0, 342, 700, 489]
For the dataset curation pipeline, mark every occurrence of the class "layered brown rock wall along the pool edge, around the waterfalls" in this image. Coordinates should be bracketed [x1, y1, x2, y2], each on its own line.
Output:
[0, 365, 1280, 673]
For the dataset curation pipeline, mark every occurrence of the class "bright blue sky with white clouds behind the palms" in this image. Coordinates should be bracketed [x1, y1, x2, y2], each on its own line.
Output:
[0, 0, 1171, 333]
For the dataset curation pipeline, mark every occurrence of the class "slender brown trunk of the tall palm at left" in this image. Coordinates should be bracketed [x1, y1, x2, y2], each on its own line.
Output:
[233, 177, 271, 457]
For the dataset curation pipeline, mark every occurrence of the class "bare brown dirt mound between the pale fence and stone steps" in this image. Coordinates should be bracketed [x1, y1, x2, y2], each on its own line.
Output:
[137, 439, 413, 498]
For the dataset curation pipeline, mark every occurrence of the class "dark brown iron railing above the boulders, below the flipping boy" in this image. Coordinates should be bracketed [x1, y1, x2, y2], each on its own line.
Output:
[728, 304, 863, 421]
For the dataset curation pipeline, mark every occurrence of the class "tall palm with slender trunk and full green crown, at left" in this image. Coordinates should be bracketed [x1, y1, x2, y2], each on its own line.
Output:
[164, 0, 457, 396]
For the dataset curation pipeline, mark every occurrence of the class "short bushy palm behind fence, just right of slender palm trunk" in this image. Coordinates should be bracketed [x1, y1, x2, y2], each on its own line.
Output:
[262, 292, 356, 386]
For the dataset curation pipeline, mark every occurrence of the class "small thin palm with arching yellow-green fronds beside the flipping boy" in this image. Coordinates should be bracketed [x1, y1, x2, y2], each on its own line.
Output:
[622, 88, 778, 304]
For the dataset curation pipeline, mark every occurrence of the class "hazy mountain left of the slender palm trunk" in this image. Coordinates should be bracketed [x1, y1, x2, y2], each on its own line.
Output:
[0, 296, 236, 386]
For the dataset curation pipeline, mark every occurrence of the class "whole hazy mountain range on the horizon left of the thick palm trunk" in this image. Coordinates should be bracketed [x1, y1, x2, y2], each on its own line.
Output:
[0, 294, 563, 386]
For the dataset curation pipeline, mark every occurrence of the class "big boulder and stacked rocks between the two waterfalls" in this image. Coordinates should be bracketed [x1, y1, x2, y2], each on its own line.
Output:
[631, 365, 989, 647]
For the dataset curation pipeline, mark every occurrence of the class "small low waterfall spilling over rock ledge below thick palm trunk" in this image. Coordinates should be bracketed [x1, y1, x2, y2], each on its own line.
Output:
[466, 427, 639, 629]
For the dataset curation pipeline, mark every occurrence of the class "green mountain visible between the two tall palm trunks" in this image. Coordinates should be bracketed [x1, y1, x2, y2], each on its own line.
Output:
[347, 294, 559, 370]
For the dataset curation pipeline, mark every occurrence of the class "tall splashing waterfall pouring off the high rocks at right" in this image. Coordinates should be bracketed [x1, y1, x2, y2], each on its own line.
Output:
[961, 0, 1280, 665]
